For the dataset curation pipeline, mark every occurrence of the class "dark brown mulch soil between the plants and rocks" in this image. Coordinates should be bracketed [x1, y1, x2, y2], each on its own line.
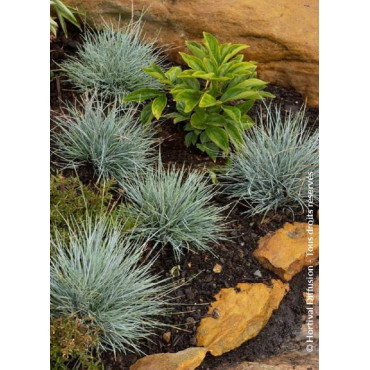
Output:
[50, 24, 319, 369]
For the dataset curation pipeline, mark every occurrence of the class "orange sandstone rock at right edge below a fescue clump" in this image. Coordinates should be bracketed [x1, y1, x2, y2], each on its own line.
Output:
[253, 222, 319, 281]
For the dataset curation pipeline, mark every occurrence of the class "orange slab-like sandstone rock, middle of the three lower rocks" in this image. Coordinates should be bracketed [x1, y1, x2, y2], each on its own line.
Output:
[196, 280, 289, 356]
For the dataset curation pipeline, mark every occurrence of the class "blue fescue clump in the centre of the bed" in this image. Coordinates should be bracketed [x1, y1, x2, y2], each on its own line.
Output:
[126, 163, 224, 260]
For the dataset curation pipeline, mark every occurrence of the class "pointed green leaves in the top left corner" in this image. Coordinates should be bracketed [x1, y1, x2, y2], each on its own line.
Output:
[50, 0, 83, 37]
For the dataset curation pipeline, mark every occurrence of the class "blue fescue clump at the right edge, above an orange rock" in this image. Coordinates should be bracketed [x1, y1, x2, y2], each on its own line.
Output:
[221, 107, 319, 216]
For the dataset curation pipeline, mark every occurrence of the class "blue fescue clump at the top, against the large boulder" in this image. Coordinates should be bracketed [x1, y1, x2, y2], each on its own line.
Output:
[61, 20, 164, 99]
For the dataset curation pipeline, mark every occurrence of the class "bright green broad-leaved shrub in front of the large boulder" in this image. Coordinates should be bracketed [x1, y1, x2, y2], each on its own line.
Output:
[123, 32, 274, 161]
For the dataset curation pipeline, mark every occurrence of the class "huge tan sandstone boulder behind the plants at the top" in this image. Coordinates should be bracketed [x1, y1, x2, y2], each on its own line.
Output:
[66, 0, 319, 105]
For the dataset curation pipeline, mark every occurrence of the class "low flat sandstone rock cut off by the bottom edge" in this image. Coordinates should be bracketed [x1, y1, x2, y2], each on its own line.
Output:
[130, 347, 207, 370]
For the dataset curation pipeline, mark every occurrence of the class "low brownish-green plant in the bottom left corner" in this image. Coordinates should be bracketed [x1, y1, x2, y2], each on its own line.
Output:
[50, 317, 102, 370]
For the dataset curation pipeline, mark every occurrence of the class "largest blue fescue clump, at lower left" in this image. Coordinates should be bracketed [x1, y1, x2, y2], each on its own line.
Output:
[50, 217, 173, 353]
